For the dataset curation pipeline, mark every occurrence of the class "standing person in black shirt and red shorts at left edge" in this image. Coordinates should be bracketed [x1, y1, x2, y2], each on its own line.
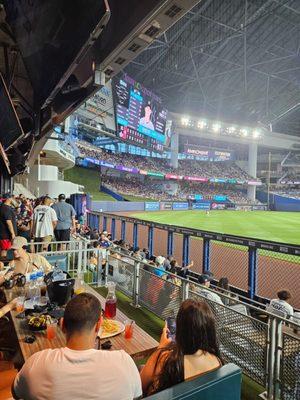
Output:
[0, 193, 17, 257]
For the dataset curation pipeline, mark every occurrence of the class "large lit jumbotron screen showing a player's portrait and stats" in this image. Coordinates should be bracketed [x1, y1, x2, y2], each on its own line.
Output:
[113, 74, 170, 151]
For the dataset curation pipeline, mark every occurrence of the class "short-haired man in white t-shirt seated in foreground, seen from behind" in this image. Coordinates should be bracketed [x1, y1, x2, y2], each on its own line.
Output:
[12, 293, 142, 400]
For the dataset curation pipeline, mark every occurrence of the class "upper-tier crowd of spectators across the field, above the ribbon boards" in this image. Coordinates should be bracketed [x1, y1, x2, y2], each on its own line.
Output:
[76, 141, 251, 181]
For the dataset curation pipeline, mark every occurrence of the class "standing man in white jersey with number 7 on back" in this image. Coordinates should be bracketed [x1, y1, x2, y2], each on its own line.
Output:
[32, 196, 57, 251]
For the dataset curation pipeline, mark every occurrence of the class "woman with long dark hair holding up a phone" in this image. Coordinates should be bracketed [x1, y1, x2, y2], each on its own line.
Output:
[141, 299, 222, 395]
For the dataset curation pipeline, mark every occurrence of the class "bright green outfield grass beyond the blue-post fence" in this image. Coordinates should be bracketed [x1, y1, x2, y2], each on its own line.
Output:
[133, 210, 300, 245]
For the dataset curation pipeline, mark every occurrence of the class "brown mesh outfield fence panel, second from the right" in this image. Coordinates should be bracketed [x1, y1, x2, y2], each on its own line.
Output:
[210, 241, 248, 291]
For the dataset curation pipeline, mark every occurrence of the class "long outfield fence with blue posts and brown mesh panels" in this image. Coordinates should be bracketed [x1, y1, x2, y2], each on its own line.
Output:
[88, 209, 300, 309]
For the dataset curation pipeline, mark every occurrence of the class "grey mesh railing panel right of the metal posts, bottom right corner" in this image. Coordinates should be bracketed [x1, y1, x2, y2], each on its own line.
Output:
[280, 333, 300, 400]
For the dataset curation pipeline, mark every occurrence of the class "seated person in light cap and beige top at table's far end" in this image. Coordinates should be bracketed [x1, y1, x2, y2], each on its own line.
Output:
[9, 236, 52, 275]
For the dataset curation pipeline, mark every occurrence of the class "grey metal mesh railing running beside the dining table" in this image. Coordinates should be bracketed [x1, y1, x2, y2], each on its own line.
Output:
[34, 241, 300, 400]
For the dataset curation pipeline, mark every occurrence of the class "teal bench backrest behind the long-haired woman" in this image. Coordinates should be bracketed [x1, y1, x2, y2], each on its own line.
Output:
[147, 364, 242, 400]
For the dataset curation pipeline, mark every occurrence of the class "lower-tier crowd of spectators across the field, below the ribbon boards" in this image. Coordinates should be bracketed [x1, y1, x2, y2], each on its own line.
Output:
[102, 176, 259, 205]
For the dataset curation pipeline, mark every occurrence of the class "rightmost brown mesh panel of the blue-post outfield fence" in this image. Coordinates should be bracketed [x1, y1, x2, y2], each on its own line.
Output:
[257, 250, 300, 308]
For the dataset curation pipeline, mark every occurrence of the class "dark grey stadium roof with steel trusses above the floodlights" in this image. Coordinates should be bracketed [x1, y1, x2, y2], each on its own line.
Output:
[126, 0, 300, 135]
